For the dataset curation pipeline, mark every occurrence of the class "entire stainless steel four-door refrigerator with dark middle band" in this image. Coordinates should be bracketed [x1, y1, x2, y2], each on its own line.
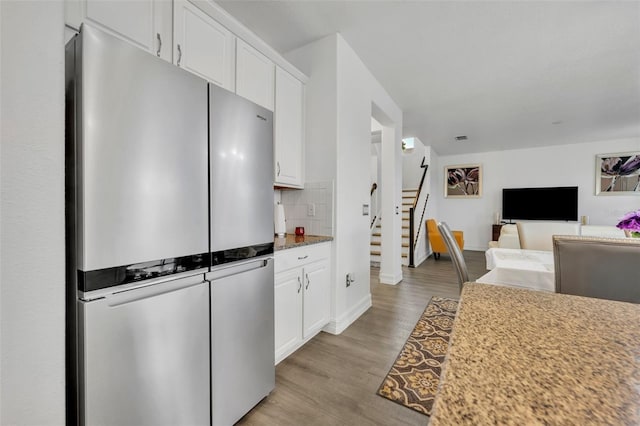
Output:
[65, 24, 274, 425]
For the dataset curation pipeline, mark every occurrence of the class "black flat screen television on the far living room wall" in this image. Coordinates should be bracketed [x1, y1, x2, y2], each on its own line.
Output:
[502, 186, 578, 221]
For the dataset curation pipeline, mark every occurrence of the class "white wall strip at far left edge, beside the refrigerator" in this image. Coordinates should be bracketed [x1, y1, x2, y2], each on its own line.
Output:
[0, 0, 65, 425]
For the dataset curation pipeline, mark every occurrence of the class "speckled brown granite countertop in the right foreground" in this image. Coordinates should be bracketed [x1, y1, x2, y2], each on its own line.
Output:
[429, 283, 640, 426]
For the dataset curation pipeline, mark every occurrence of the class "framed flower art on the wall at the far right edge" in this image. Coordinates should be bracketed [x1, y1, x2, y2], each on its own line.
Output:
[596, 152, 640, 195]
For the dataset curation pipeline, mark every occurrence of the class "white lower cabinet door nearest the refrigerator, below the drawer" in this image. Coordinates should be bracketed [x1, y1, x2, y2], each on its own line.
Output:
[274, 268, 303, 364]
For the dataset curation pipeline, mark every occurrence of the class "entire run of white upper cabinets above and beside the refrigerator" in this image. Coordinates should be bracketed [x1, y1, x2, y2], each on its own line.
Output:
[66, 0, 307, 188]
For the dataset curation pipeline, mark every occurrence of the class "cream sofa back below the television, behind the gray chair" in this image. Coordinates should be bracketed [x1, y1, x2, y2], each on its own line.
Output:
[489, 222, 625, 251]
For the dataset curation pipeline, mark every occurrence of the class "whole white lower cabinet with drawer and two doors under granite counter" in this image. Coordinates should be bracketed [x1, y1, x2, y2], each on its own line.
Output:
[274, 243, 331, 364]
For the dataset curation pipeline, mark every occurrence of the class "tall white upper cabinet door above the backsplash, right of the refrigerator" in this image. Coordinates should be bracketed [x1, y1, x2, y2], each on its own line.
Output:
[274, 67, 304, 188]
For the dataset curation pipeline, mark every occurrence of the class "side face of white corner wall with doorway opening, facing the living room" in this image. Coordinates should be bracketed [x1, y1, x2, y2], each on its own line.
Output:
[336, 35, 402, 320]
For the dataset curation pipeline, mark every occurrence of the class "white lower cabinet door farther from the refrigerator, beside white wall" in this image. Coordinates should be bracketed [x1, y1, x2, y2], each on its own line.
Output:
[302, 259, 330, 339]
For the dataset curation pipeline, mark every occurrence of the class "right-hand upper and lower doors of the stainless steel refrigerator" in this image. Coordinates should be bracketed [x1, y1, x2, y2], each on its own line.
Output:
[206, 84, 275, 426]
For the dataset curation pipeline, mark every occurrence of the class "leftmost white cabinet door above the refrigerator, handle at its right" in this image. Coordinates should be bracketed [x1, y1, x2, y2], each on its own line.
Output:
[65, 0, 173, 61]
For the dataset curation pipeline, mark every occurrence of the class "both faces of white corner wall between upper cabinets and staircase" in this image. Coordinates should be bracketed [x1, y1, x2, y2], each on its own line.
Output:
[286, 34, 402, 333]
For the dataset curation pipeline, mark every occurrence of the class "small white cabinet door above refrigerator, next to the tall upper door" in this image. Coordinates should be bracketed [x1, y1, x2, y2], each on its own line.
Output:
[236, 39, 275, 111]
